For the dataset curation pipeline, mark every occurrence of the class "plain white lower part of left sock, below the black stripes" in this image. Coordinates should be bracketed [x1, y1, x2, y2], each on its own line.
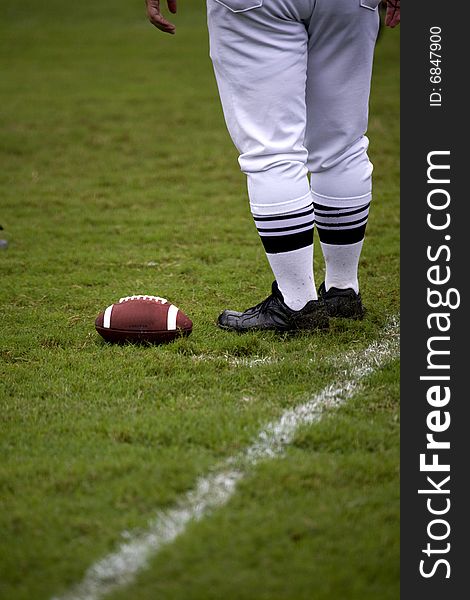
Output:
[266, 245, 318, 310]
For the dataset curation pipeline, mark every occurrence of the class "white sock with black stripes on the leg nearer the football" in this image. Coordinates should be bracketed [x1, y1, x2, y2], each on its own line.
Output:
[253, 204, 317, 310]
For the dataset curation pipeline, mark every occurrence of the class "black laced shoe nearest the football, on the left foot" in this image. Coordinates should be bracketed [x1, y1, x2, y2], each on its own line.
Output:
[217, 282, 329, 333]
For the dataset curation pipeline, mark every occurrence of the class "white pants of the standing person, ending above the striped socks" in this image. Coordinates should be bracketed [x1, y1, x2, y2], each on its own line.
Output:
[207, 0, 380, 215]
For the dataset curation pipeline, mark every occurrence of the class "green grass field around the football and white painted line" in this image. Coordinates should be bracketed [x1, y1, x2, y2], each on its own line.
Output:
[0, 0, 399, 600]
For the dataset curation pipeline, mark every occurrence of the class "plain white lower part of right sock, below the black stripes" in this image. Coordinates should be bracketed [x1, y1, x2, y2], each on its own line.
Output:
[320, 240, 364, 294]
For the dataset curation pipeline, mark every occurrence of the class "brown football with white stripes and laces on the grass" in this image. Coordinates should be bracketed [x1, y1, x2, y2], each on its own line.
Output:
[95, 295, 193, 344]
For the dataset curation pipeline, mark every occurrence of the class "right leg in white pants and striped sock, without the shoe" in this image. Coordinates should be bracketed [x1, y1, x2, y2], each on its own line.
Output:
[306, 0, 379, 316]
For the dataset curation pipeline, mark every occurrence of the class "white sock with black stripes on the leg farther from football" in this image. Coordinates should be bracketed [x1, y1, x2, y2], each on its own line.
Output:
[314, 202, 370, 293]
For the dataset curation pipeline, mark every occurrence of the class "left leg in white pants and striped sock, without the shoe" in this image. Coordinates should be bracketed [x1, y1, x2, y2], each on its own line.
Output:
[208, 0, 317, 311]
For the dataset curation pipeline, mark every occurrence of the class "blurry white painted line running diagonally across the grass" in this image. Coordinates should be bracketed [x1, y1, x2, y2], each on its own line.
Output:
[52, 318, 400, 600]
